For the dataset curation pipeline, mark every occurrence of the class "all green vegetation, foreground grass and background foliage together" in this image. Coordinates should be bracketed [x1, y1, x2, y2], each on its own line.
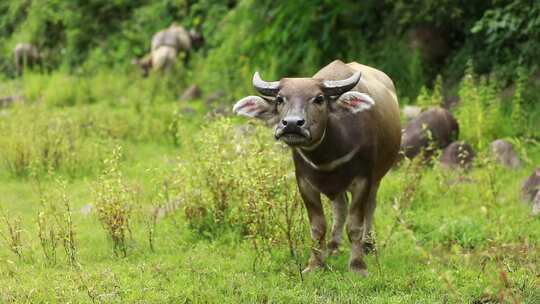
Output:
[0, 0, 540, 303]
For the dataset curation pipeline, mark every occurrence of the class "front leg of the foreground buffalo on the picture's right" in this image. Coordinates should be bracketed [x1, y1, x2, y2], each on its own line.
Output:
[347, 179, 372, 276]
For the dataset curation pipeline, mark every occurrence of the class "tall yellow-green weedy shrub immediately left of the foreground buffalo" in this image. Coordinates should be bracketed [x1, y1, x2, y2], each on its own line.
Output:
[181, 118, 303, 250]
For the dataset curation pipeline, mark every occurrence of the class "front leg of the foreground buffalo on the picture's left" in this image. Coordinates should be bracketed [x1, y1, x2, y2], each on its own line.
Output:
[297, 178, 326, 273]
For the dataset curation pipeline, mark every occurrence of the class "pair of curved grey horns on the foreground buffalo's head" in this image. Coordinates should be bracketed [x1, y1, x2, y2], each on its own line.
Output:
[253, 71, 362, 96]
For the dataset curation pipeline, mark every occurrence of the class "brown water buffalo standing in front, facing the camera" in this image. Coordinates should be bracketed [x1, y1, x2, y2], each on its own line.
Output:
[233, 60, 401, 275]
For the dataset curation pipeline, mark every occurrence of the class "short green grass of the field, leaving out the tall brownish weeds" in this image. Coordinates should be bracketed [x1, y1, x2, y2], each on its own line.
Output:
[0, 72, 540, 303]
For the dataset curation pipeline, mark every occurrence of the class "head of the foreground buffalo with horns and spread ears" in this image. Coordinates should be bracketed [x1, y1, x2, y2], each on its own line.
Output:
[233, 72, 375, 149]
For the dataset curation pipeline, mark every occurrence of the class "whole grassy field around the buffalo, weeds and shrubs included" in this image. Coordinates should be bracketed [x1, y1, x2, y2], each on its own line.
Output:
[0, 70, 540, 303]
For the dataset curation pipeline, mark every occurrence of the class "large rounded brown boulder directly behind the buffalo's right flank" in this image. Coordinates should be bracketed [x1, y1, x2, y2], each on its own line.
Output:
[401, 107, 459, 159]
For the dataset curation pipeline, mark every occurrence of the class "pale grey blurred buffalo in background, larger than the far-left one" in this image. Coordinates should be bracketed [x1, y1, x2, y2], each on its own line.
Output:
[133, 23, 203, 76]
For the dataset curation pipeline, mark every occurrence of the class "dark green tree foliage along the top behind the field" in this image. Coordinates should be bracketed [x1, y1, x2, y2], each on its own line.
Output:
[0, 0, 540, 98]
